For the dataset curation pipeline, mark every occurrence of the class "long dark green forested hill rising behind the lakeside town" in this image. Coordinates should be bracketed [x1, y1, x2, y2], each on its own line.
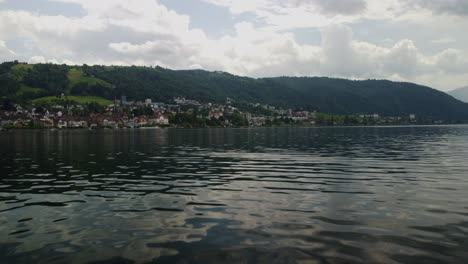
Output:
[0, 62, 468, 120]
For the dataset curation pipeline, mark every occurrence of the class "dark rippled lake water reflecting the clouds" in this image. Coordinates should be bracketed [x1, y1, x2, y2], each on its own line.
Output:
[0, 126, 468, 263]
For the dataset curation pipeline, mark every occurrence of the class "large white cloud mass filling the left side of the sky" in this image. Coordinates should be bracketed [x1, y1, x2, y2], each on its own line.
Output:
[0, 0, 206, 67]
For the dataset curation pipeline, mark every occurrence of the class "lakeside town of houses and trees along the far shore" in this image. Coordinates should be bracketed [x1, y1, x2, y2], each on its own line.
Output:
[0, 95, 426, 129]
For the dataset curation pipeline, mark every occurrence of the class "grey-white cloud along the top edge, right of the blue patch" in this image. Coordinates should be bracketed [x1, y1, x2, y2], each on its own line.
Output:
[204, 0, 405, 29]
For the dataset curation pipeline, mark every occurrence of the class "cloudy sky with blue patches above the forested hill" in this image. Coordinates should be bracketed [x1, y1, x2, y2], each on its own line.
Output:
[0, 0, 468, 91]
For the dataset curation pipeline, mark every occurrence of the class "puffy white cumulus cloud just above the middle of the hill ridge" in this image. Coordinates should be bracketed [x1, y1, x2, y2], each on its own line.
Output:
[198, 23, 319, 76]
